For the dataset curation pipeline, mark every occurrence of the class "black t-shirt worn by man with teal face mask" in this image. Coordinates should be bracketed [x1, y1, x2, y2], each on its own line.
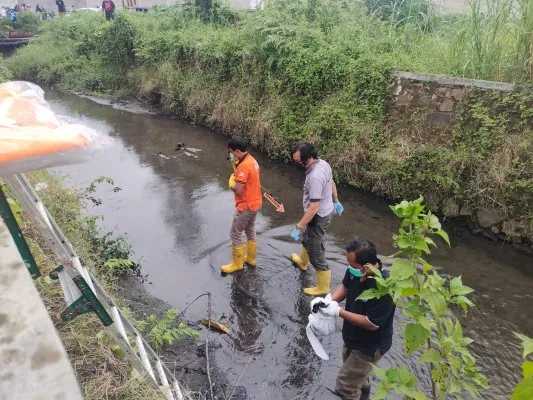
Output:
[342, 270, 396, 355]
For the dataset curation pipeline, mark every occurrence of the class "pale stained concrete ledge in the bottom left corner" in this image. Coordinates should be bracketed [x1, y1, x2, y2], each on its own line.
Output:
[0, 218, 82, 400]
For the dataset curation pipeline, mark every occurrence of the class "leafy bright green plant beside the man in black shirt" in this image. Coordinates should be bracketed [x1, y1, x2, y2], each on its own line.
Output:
[359, 197, 487, 400]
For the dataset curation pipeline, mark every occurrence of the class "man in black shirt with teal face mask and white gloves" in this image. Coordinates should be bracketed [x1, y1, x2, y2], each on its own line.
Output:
[321, 240, 396, 400]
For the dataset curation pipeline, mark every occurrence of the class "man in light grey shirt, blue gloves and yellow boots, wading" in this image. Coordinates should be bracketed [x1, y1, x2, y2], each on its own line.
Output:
[291, 142, 344, 296]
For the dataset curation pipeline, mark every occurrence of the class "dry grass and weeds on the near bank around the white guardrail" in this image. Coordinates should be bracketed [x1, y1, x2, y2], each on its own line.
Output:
[10, 171, 198, 400]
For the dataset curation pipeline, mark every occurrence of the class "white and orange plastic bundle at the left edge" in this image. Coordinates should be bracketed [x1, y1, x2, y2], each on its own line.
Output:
[0, 81, 113, 175]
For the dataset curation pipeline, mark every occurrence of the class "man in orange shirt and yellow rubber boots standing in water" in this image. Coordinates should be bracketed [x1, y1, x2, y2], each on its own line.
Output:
[220, 137, 263, 274]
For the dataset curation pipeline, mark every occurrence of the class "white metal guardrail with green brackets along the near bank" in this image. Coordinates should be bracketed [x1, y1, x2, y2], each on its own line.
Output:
[2, 174, 183, 400]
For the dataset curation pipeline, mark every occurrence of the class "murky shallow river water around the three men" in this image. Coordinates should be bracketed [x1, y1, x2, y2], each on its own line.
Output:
[47, 90, 533, 399]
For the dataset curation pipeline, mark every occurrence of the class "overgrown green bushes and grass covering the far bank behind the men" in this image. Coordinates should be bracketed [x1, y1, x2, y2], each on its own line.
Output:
[8, 0, 533, 237]
